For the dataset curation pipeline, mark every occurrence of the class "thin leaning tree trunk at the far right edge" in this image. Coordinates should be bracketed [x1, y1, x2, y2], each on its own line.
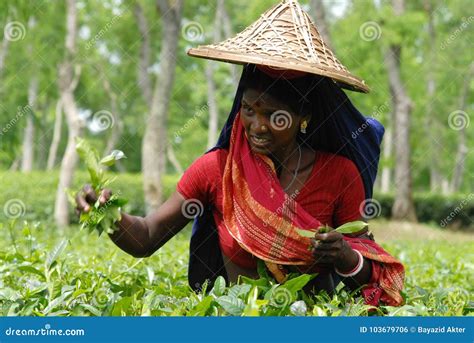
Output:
[449, 62, 474, 192]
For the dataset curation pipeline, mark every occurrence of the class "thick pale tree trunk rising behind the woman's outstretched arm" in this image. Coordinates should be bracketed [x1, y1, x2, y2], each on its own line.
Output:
[142, 0, 183, 212]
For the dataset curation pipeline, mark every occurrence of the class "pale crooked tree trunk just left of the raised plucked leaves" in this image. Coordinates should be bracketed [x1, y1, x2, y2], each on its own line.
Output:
[54, 0, 83, 227]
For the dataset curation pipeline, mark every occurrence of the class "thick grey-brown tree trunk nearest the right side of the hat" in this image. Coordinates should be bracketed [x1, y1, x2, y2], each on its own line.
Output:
[385, 0, 416, 221]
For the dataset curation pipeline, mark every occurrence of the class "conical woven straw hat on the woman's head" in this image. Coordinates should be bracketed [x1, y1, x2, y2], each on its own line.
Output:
[188, 0, 369, 93]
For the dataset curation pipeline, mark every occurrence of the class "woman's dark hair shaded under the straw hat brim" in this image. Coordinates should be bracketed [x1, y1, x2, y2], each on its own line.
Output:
[242, 65, 323, 116]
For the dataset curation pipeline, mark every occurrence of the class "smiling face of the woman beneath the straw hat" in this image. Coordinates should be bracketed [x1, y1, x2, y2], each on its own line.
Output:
[240, 89, 308, 155]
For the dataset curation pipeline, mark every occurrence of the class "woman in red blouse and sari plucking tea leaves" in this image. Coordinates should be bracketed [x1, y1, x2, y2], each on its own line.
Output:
[77, 1, 403, 305]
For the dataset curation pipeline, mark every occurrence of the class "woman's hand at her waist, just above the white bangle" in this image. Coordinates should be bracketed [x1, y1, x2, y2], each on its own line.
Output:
[311, 231, 358, 270]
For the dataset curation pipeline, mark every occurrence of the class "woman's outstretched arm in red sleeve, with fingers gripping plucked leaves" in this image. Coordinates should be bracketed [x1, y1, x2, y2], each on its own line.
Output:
[76, 151, 221, 257]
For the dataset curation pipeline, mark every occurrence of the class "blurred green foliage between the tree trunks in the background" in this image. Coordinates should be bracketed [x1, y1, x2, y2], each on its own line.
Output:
[0, 0, 474, 193]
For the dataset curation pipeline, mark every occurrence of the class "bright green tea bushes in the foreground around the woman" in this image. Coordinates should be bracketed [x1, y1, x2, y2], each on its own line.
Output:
[0, 221, 474, 316]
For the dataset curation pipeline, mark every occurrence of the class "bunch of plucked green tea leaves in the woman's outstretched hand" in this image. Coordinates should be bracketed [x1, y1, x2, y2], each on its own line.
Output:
[68, 138, 127, 235]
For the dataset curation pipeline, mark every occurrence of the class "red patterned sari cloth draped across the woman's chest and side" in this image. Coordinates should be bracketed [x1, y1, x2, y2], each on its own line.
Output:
[222, 114, 404, 306]
